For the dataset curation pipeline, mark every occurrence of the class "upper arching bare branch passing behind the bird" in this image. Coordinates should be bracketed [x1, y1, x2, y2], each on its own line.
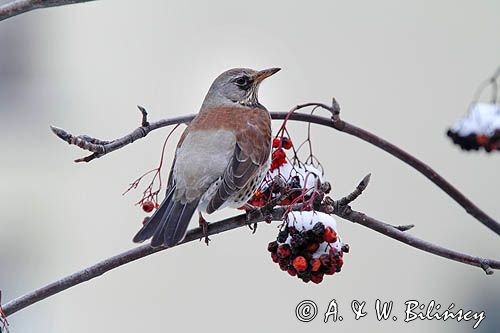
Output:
[51, 100, 500, 235]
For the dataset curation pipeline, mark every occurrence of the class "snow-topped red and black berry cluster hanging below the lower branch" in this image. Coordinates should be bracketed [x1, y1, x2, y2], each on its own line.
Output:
[268, 211, 349, 283]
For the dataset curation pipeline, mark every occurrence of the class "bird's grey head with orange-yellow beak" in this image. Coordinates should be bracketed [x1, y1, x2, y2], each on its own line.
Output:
[202, 68, 280, 108]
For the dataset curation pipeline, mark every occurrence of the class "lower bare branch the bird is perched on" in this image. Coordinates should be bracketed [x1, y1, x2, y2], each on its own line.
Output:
[2, 176, 500, 316]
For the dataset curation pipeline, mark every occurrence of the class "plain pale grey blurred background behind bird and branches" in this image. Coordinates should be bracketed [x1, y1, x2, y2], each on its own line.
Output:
[0, 0, 500, 332]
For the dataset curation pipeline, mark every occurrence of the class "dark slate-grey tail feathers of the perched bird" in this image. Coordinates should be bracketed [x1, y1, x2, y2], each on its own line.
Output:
[133, 186, 199, 247]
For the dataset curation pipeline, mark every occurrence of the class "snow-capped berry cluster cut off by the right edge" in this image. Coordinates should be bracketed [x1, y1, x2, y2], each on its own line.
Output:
[447, 103, 500, 152]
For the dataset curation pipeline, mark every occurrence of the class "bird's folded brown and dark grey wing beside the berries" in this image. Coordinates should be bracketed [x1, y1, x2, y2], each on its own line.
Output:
[207, 110, 271, 214]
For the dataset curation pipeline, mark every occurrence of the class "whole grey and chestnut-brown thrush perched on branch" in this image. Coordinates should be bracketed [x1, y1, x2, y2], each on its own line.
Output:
[133, 68, 280, 247]
